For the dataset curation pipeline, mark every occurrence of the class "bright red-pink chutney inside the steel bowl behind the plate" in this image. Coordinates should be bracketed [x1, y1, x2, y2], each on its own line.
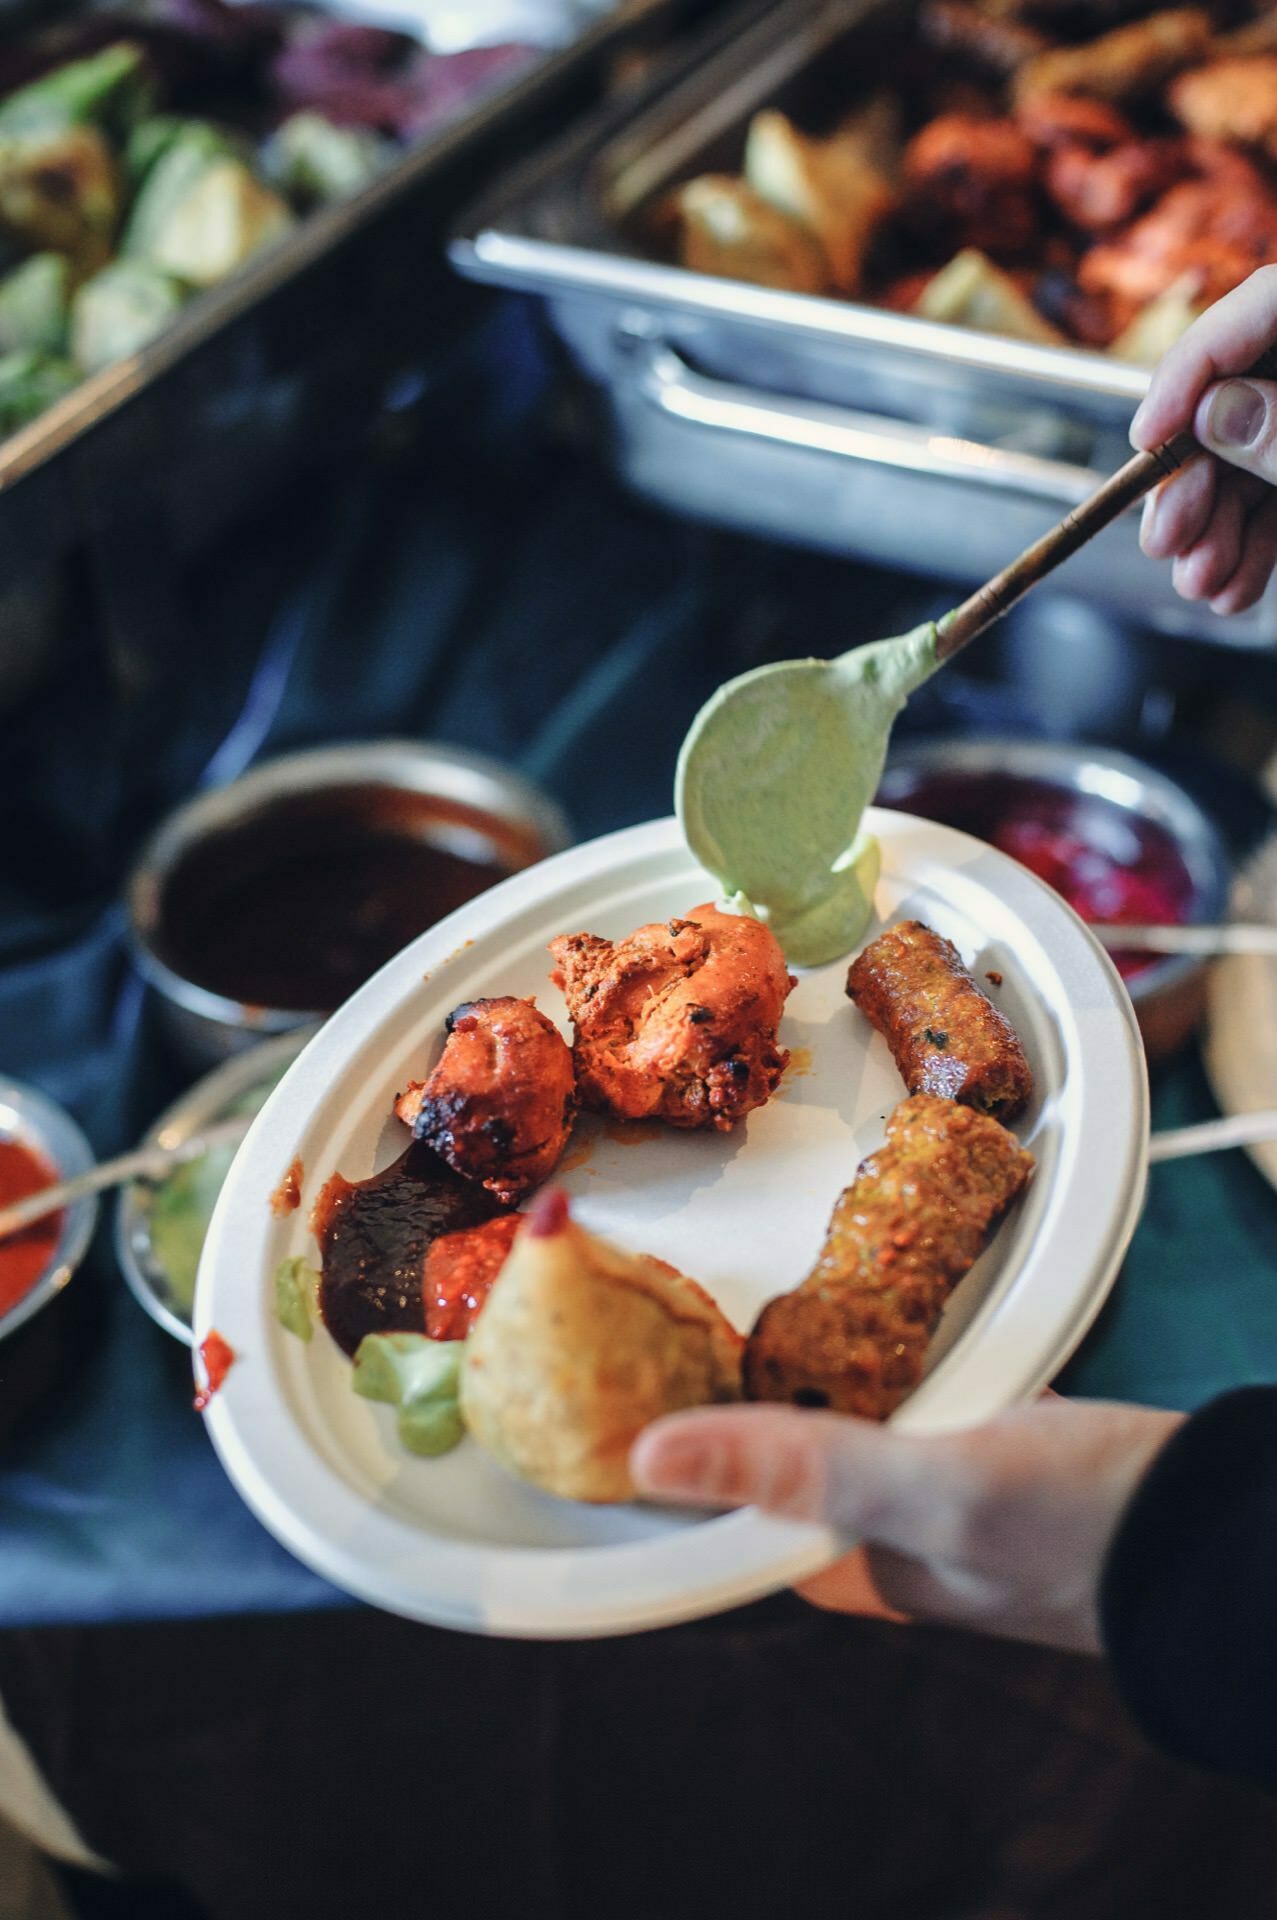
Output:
[875, 772, 1194, 979]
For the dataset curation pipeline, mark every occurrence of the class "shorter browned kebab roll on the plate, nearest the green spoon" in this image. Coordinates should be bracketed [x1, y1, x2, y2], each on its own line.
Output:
[847, 920, 1033, 1119]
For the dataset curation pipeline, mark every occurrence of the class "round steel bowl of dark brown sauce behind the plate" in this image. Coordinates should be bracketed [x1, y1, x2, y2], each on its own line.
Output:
[129, 739, 570, 1068]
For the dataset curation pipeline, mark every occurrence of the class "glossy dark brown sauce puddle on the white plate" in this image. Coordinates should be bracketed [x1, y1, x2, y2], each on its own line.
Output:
[311, 1142, 505, 1356]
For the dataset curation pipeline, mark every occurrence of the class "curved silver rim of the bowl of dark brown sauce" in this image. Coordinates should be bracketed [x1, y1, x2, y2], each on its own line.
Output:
[125, 739, 572, 1037]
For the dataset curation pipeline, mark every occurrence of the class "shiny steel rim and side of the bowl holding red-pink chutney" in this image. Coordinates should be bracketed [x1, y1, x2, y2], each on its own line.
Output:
[878, 737, 1231, 1060]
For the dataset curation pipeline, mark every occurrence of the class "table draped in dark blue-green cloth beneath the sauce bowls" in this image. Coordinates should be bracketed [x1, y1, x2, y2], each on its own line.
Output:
[0, 305, 1277, 1920]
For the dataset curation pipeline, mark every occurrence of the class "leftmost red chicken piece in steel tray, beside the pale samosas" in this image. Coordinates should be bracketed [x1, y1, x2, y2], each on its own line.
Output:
[904, 113, 1039, 257]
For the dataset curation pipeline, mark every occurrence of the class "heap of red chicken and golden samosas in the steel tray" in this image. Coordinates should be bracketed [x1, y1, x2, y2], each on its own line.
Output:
[649, 0, 1277, 365]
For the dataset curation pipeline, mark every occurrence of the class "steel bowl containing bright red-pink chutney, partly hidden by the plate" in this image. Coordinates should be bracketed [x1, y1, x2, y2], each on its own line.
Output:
[878, 737, 1231, 1060]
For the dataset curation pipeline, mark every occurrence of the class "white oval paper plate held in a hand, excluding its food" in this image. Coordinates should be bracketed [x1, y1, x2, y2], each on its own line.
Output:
[194, 812, 1148, 1638]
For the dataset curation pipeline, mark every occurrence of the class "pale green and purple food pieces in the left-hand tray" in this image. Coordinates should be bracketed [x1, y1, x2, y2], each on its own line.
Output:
[0, 0, 534, 434]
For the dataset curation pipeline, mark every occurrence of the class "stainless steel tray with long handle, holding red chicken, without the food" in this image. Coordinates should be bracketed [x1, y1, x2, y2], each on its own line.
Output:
[451, 0, 1277, 647]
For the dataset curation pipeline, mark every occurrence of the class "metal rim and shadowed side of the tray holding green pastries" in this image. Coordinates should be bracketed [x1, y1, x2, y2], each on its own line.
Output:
[0, 0, 716, 579]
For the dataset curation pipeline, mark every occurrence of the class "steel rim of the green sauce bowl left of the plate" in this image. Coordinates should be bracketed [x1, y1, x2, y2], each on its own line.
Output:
[115, 1025, 317, 1346]
